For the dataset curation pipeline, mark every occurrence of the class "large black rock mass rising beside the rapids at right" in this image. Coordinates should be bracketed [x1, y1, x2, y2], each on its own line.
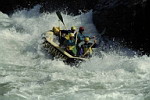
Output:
[93, 0, 150, 53]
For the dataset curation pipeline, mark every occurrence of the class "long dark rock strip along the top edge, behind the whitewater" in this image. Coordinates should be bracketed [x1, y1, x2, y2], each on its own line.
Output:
[0, 0, 98, 15]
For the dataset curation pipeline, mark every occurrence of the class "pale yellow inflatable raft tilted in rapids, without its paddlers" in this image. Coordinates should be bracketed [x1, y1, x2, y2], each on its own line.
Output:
[43, 31, 87, 65]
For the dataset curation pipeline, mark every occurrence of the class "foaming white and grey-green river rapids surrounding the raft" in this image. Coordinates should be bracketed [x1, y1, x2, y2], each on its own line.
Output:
[0, 5, 150, 100]
